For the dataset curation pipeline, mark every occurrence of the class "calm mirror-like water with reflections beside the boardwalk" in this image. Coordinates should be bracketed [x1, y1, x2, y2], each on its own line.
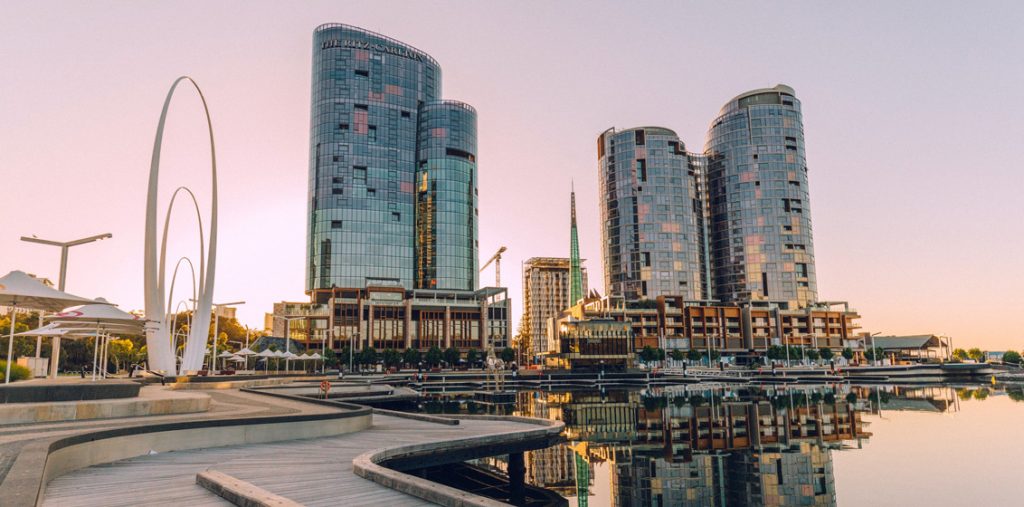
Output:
[411, 386, 1024, 507]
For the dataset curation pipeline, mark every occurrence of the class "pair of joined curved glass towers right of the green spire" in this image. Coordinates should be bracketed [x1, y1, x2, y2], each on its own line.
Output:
[597, 85, 817, 309]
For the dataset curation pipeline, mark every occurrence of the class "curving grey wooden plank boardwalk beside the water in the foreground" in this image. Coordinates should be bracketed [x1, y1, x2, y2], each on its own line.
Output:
[43, 415, 536, 507]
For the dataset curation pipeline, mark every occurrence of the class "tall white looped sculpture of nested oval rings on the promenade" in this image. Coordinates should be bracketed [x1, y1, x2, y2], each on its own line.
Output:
[144, 76, 217, 374]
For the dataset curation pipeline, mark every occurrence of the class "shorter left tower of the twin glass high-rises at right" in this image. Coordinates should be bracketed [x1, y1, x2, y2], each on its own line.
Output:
[597, 127, 707, 300]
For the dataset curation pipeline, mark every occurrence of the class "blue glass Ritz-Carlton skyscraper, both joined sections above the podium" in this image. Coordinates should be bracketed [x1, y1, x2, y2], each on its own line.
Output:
[306, 24, 477, 292]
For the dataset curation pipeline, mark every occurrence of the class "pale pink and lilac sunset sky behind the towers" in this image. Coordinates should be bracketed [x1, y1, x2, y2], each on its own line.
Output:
[0, 1, 1024, 349]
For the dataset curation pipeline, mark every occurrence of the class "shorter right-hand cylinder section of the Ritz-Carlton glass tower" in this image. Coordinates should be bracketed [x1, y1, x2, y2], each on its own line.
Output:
[416, 100, 477, 291]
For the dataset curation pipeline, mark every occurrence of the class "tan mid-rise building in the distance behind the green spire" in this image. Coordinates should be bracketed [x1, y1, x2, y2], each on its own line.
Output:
[521, 257, 588, 355]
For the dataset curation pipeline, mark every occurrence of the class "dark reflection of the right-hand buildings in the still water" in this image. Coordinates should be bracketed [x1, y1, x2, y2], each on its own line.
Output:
[479, 386, 956, 507]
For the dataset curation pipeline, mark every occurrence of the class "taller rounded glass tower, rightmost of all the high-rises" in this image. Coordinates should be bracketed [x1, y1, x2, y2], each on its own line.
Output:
[705, 85, 817, 308]
